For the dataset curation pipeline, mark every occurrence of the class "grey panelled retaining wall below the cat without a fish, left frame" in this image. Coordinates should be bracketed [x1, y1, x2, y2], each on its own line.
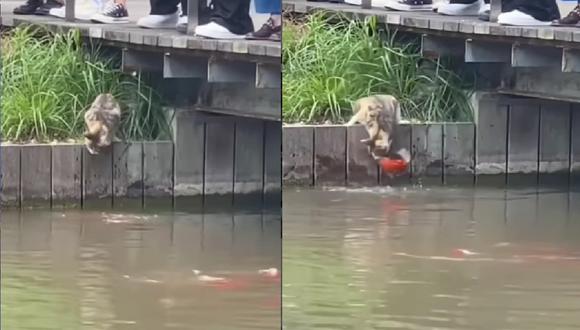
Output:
[0, 111, 281, 207]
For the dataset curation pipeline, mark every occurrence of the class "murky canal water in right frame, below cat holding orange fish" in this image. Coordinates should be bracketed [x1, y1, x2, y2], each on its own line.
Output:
[283, 188, 580, 330]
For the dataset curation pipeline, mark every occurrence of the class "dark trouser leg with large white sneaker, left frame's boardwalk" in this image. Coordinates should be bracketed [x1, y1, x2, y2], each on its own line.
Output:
[195, 0, 254, 39]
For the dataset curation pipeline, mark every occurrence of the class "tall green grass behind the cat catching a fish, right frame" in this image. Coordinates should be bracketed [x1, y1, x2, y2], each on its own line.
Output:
[282, 13, 472, 123]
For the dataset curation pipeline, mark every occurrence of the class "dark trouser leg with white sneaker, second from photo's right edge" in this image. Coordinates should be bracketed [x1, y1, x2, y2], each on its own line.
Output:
[498, 0, 560, 26]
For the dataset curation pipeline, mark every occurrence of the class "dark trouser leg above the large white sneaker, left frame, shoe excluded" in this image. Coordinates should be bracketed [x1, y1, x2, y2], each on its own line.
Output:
[211, 0, 254, 34]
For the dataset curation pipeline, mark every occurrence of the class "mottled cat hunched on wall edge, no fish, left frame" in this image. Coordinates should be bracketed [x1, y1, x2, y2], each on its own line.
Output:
[84, 93, 121, 155]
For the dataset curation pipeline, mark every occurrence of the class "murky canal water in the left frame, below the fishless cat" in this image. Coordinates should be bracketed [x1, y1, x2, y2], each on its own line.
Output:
[1, 211, 281, 330]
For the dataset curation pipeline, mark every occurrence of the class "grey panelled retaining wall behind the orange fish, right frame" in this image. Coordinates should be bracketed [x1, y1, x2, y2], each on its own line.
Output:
[283, 94, 580, 186]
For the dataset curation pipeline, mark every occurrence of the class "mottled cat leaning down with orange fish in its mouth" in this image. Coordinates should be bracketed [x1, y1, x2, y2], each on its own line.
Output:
[347, 95, 401, 159]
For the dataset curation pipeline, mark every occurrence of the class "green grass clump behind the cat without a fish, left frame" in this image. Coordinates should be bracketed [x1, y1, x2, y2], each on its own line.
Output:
[0, 27, 169, 142]
